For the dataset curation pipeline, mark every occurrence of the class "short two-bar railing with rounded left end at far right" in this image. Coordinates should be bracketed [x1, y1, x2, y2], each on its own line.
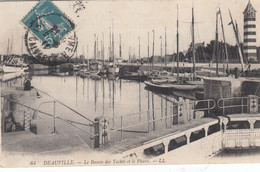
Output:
[217, 97, 248, 115]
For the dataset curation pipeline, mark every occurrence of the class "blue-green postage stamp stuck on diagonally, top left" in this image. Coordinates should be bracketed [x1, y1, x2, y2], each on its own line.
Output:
[22, 0, 75, 48]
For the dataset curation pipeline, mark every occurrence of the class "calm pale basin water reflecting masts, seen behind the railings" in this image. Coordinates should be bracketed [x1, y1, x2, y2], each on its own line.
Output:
[1, 75, 199, 144]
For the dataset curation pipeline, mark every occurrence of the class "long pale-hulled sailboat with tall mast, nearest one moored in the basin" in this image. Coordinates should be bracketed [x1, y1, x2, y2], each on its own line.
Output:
[144, 6, 197, 91]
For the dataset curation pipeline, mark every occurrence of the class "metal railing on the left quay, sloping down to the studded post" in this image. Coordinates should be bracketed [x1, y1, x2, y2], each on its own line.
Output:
[2, 94, 97, 147]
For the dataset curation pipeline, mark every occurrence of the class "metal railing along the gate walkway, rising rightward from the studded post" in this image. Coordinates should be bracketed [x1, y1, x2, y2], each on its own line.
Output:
[111, 99, 216, 141]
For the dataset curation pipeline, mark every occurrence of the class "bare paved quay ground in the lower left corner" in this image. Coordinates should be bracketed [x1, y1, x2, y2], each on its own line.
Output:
[2, 131, 92, 155]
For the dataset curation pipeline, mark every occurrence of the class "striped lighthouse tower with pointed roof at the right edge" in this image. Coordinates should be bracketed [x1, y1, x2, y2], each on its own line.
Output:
[243, 0, 257, 62]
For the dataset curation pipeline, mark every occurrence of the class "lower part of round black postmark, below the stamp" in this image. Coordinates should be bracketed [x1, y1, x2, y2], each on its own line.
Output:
[24, 31, 78, 66]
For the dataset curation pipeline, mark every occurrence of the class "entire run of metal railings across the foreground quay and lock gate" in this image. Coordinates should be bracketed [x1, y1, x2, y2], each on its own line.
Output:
[5, 92, 260, 148]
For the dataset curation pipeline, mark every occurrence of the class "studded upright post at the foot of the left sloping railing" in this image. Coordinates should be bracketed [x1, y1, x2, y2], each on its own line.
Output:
[94, 116, 110, 148]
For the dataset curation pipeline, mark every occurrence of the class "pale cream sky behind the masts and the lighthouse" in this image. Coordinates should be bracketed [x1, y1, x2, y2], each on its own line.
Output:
[0, 0, 260, 59]
